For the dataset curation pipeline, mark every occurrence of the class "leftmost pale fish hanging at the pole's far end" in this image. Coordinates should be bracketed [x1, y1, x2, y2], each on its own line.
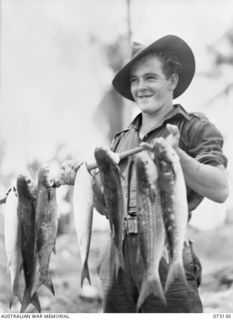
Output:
[4, 186, 23, 308]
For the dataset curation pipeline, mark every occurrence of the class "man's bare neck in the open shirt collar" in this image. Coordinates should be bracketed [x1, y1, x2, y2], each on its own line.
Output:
[139, 105, 173, 139]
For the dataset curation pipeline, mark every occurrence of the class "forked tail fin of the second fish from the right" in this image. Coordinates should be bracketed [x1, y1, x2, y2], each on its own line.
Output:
[137, 274, 167, 310]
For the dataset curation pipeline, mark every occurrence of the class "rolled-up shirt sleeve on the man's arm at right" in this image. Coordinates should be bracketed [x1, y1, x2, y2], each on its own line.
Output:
[188, 118, 227, 167]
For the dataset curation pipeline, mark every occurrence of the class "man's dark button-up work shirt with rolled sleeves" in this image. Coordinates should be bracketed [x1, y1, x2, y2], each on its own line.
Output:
[111, 104, 227, 219]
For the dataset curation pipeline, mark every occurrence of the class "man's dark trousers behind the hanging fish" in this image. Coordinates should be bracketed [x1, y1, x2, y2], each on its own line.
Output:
[98, 234, 203, 313]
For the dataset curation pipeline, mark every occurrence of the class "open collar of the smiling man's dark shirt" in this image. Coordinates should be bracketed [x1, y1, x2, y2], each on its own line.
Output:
[129, 104, 190, 131]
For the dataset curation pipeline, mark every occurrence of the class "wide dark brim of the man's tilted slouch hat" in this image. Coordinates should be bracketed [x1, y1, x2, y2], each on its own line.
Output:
[112, 35, 195, 101]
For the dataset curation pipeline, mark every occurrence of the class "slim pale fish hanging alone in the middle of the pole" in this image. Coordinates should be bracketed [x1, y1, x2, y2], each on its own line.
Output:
[73, 163, 94, 288]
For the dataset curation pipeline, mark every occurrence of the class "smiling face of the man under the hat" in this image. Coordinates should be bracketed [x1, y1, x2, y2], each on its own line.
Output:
[130, 54, 178, 114]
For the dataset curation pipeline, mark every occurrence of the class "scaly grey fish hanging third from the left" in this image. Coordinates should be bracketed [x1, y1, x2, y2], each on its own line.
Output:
[33, 164, 58, 295]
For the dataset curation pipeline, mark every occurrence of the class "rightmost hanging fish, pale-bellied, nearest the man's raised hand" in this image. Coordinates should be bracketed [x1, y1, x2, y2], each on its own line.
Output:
[154, 138, 188, 292]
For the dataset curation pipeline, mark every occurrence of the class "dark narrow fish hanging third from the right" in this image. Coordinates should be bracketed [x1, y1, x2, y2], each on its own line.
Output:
[94, 148, 126, 277]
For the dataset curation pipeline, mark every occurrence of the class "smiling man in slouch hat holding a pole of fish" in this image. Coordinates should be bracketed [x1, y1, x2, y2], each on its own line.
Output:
[95, 35, 228, 313]
